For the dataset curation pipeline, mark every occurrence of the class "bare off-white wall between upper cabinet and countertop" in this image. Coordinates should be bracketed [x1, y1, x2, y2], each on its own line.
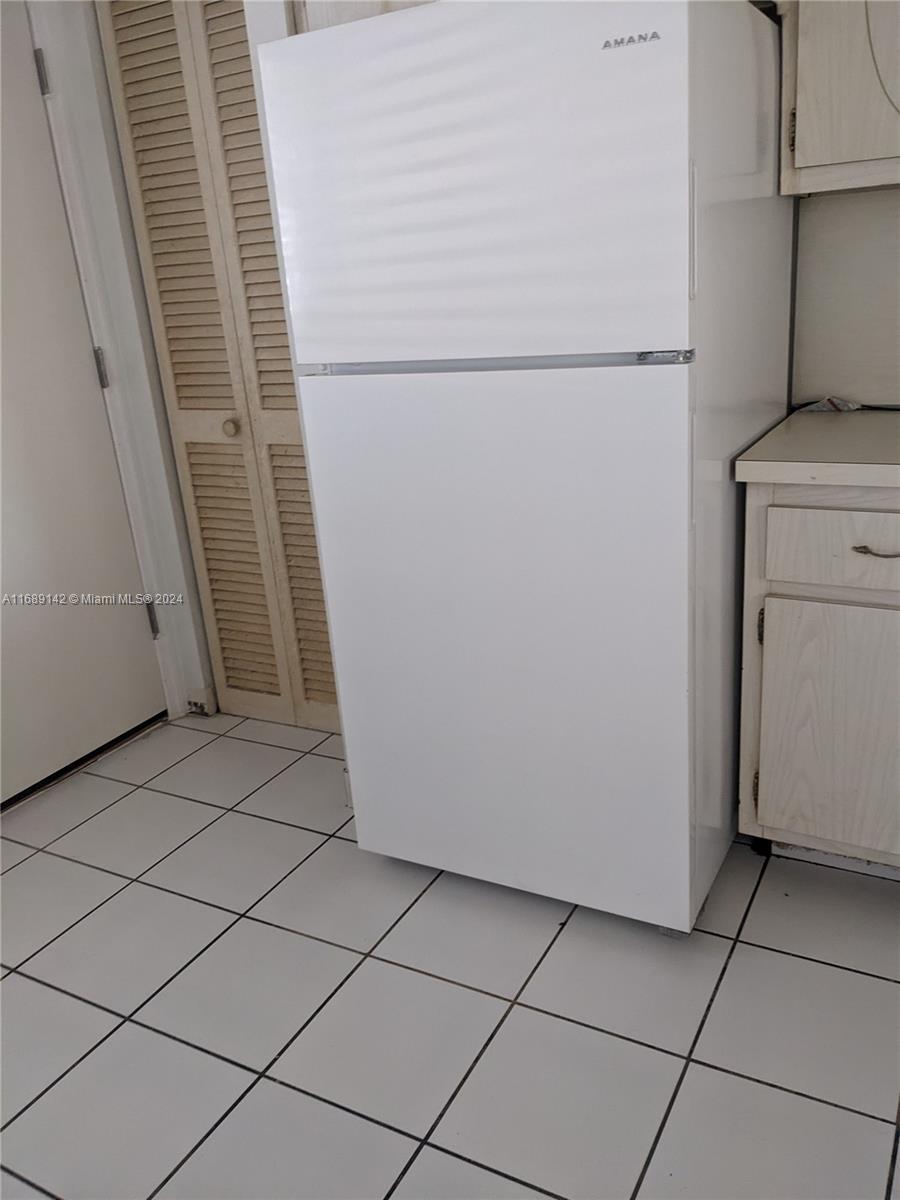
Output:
[793, 187, 900, 404]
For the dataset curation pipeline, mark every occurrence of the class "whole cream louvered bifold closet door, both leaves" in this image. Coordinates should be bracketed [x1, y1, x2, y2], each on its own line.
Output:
[96, 0, 337, 728]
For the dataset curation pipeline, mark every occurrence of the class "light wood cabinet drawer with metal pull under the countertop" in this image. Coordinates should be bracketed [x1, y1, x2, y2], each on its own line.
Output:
[766, 506, 900, 590]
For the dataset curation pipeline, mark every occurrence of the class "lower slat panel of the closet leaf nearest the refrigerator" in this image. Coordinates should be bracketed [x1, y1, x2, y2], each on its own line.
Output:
[270, 445, 337, 704]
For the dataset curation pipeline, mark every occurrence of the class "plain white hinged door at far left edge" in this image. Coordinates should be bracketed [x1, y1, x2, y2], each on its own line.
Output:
[1, 2, 164, 799]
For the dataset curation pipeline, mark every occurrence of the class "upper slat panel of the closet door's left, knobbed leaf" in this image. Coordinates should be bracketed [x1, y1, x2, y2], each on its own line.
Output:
[112, 0, 234, 408]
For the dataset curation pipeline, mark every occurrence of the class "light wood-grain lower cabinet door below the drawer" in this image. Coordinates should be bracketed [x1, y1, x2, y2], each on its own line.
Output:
[758, 596, 900, 853]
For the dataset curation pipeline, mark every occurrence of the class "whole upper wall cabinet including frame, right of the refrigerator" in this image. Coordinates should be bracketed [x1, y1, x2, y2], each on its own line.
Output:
[779, 0, 900, 194]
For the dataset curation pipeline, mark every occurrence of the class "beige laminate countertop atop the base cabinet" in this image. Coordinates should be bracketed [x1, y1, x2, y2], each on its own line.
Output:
[736, 409, 900, 487]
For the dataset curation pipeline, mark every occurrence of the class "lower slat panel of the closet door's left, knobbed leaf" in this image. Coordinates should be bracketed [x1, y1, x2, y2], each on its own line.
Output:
[187, 443, 280, 695]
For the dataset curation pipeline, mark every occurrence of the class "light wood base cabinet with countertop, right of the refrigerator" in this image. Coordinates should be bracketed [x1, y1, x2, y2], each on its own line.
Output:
[737, 412, 900, 866]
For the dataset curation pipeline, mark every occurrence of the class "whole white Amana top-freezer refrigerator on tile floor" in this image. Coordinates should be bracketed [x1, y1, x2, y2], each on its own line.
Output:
[259, 0, 791, 930]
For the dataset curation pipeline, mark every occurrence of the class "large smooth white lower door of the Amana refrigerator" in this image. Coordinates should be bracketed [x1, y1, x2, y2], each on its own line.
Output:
[301, 366, 690, 929]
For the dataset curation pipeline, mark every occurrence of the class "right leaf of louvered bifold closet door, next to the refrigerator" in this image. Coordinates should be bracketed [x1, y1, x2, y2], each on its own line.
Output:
[185, 0, 336, 727]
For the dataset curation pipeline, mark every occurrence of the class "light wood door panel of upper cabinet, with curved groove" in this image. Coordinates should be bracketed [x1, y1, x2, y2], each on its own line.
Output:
[793, 0, 900, 167]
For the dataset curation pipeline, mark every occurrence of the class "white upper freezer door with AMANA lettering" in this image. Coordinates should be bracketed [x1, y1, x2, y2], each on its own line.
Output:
[259, 0, 690, 364]
